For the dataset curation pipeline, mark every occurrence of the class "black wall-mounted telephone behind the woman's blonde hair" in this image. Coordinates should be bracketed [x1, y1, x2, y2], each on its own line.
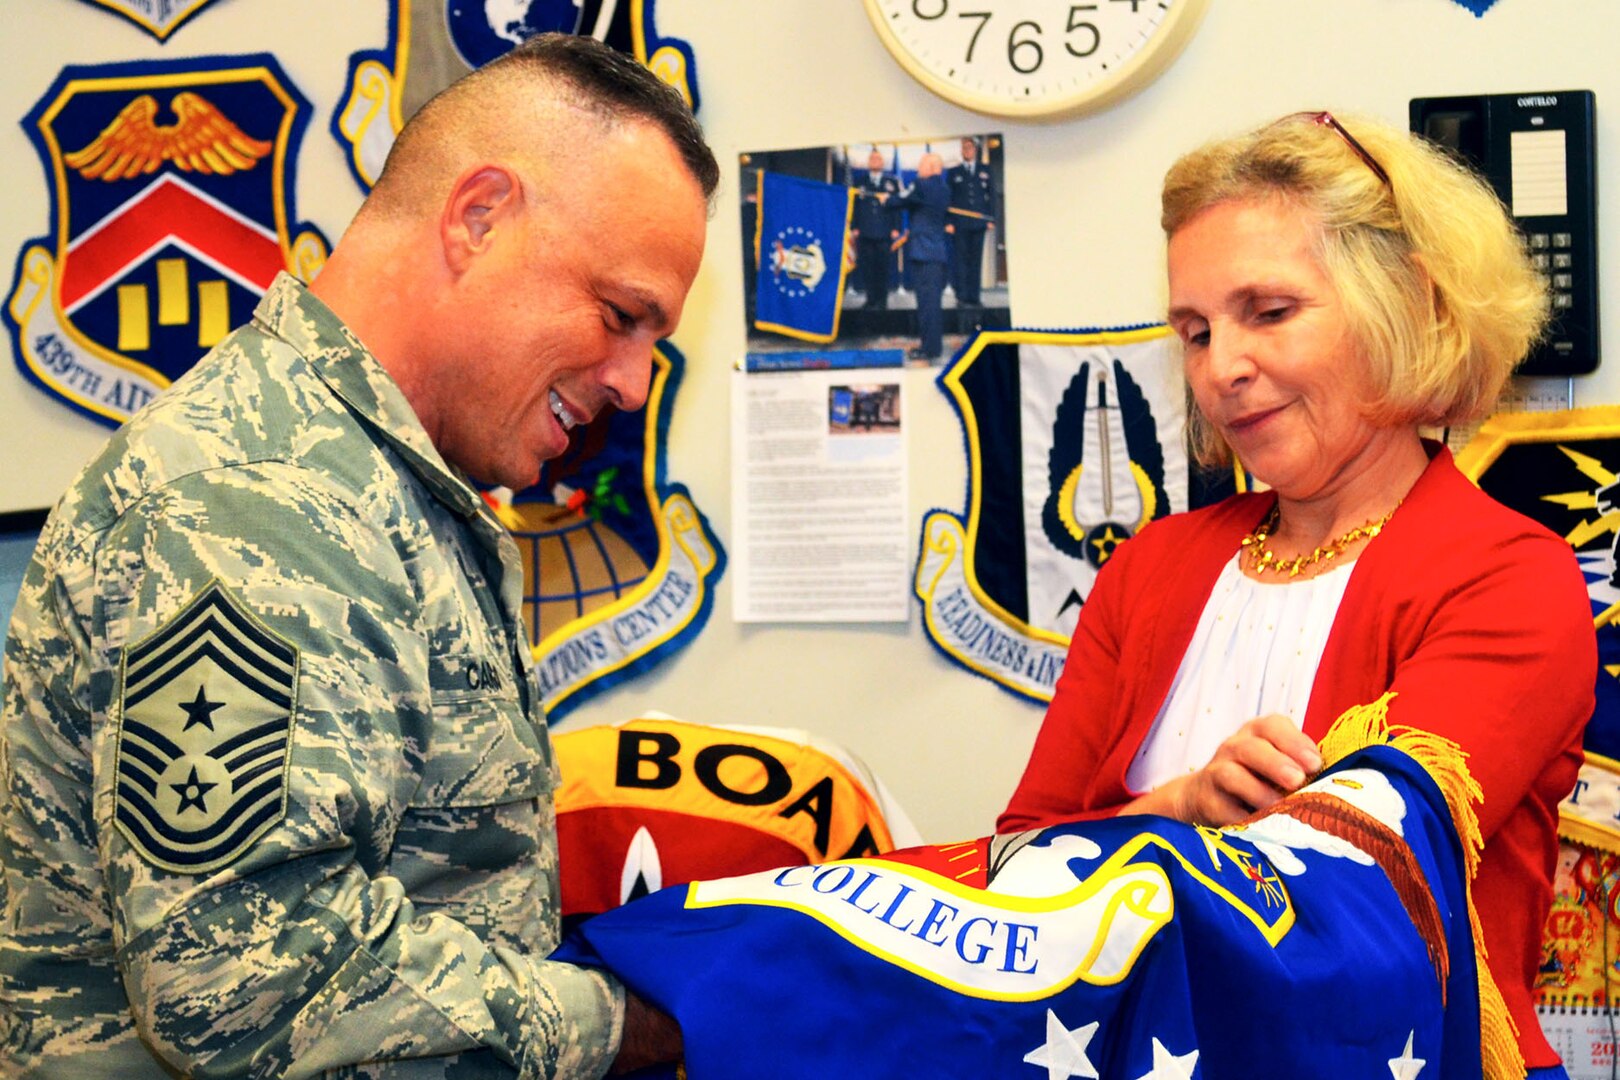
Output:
[1411, 91, 1597, 376]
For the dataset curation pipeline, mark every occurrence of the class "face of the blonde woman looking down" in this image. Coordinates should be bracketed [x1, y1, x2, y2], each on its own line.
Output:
[1170, 199, 1390, 499]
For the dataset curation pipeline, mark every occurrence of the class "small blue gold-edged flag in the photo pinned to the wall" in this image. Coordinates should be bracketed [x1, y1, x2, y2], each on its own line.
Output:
[753, 172, 855, 342]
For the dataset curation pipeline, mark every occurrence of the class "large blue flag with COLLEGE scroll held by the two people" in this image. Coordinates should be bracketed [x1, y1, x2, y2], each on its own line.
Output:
[559, 745, 1482, 1080]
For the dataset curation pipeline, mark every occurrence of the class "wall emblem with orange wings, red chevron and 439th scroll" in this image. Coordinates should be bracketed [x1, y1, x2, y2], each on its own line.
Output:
[3, 53, 327, 424]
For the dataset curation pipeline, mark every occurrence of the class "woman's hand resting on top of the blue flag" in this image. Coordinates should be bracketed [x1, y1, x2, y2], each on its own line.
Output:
[1124, 712, 1322, 826]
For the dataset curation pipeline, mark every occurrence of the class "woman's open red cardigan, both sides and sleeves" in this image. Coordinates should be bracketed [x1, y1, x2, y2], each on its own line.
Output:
[996, 447, 1597, 1069]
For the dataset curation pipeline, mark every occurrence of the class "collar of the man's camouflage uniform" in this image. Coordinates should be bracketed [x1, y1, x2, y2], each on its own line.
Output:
[253, 272, 486, 517]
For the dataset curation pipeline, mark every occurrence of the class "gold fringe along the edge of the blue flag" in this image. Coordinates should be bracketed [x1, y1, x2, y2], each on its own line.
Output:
[1319, 690, 1524, 1080]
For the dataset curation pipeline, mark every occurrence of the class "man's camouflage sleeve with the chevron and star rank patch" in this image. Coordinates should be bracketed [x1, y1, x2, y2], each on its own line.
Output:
[79, 465, 624, 1077]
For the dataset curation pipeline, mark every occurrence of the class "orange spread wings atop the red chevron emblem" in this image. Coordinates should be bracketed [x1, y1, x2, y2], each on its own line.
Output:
[63, 91, 275, 181]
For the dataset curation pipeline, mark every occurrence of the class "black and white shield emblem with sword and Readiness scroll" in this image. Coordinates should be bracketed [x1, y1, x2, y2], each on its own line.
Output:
[915, 325, 1191, 701]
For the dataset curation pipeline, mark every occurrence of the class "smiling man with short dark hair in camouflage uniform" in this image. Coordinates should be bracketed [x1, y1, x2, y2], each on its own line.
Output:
[0, 37, 718, 1078]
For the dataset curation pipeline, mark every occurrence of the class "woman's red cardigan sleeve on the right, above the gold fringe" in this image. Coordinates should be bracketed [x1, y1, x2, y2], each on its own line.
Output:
[1373, 533, 1597, 840]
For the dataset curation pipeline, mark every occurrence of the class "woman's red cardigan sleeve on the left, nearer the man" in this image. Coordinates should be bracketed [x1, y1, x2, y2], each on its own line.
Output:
[996, 527, 1134, 832]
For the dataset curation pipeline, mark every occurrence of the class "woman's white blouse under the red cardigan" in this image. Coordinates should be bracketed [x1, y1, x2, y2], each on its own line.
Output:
[1126, 552, 1354, 793]
